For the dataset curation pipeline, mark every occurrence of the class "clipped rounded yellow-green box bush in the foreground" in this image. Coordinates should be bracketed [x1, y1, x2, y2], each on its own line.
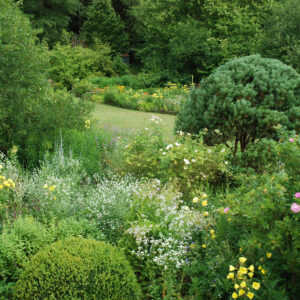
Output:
[14, 238, 140, 300]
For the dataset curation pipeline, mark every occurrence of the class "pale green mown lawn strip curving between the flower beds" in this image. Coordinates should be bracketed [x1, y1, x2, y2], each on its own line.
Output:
[92, 103, 175, 139]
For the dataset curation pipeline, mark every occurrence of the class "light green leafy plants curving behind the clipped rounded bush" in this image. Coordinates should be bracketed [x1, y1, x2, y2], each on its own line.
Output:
[0, 216, 104, 299]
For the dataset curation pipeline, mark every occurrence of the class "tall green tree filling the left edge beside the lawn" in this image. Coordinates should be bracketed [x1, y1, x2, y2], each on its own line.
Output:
[0, 0, 91, 163]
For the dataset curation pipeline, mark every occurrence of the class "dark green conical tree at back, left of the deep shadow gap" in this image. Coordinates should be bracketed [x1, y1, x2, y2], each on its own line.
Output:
[82, 0, 129, 53]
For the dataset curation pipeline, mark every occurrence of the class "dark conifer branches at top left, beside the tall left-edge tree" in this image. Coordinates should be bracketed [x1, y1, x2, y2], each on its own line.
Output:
[17, 0, 80, 47]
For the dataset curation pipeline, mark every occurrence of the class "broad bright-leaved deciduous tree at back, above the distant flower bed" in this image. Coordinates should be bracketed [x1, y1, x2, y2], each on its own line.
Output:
[131, 0, 277, 80]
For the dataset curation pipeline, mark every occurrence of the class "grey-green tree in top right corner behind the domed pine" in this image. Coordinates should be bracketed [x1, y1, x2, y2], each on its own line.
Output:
[259, 0, 300, 72]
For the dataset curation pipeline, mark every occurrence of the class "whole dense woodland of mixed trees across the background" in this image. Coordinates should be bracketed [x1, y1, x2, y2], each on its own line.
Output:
[18, 0, 300, 82]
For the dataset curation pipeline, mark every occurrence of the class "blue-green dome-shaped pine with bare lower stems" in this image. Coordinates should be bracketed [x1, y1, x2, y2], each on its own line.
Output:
[175, 55, 300, 155]
